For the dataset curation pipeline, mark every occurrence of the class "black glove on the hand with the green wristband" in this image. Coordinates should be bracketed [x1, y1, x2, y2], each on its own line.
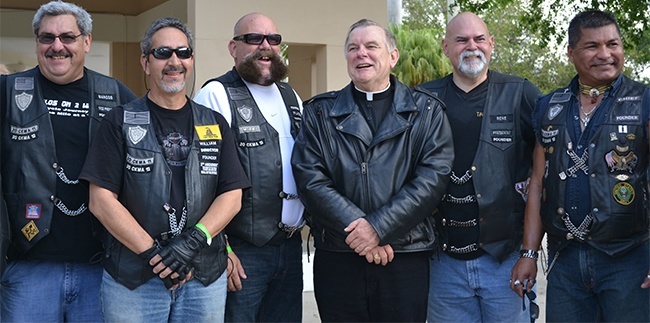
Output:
[158, 227, 208, 280]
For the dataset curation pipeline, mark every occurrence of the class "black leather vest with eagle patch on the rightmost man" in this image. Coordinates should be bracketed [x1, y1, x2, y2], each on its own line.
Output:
[540, 76, 650, 256]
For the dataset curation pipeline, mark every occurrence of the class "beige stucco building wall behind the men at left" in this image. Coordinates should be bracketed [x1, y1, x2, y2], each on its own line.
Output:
[0, 0, 387, 99]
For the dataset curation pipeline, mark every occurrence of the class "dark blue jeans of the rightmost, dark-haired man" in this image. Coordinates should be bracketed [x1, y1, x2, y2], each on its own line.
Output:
[546, 242, 650, 322]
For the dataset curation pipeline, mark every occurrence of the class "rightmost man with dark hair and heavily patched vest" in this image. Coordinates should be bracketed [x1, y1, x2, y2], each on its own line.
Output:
[511, 10, 650, 322]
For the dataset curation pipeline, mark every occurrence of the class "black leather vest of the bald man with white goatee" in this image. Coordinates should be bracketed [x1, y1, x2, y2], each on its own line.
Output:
[422, 71, 532, 261]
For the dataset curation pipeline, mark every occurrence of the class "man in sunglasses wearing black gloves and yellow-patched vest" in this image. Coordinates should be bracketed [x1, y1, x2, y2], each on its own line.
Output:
[80, 18, 249, 322]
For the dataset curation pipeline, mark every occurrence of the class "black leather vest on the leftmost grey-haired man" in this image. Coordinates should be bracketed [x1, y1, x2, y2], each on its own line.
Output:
[2, 68, 121, 253]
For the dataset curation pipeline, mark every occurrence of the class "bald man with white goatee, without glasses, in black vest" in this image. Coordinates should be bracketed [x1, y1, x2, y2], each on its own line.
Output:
[421, 12, 540, 322]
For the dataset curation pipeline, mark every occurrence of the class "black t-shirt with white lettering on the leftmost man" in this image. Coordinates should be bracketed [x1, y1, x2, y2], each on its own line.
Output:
[0, 73, 135, 263]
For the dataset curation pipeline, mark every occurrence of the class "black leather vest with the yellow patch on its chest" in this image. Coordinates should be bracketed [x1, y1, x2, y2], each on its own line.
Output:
[103, 96, 227, 289]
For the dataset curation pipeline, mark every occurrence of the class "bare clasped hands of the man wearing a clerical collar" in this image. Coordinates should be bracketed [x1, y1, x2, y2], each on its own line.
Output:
[344, 218, 395, 266]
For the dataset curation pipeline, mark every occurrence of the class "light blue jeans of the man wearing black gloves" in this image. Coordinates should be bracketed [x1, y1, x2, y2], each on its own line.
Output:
[101, 271, 228, 322]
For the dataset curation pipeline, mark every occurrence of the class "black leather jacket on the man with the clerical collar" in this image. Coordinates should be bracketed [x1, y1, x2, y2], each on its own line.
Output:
[292, 76, 454, 252]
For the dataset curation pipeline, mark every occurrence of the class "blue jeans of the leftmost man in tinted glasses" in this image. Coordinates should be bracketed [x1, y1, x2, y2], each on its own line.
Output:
[1, 260, 102, 322]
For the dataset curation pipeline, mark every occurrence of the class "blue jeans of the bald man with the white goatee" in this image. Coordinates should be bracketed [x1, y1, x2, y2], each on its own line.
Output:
[427, 252, 530, 323]
